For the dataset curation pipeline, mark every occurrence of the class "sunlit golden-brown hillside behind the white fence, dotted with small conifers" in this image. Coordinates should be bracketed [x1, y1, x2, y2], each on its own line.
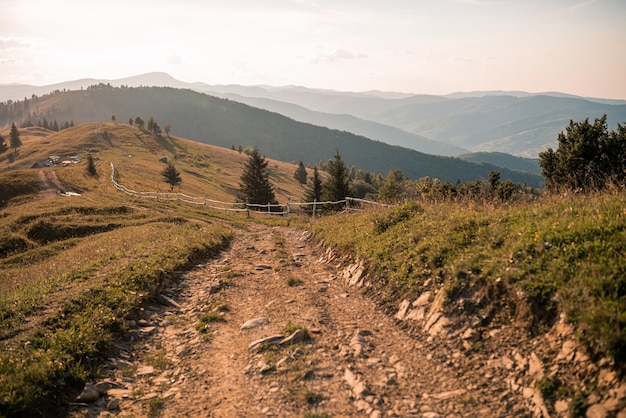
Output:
[0, 122, 304, 202]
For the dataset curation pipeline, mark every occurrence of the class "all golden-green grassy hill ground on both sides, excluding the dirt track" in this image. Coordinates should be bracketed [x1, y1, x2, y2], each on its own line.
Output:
[0, 122, 626, 416]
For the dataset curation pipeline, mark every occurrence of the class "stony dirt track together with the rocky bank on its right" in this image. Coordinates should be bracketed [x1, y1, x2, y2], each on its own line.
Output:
[70, 223, 626, 418]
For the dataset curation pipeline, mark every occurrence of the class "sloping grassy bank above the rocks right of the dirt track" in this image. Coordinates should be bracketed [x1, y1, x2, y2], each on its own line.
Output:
[314, 194, 626, 368]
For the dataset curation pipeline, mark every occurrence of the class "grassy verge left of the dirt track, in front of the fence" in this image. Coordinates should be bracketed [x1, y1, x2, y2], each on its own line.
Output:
[0, 205, 231, 416]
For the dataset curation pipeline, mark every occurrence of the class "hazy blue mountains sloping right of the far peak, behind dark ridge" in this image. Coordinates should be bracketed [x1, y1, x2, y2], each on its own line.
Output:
[193, 86, 626, 158]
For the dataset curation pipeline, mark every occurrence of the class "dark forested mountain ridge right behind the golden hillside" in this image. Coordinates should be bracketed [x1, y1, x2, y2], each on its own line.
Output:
[0, 84, 542, 186]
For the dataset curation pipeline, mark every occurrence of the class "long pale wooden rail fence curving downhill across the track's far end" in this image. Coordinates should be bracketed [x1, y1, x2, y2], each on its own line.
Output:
[110, 162, 392, 217]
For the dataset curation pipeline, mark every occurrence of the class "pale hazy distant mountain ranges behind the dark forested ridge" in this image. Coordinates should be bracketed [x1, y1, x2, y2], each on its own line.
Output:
[0, 73, 626, 158]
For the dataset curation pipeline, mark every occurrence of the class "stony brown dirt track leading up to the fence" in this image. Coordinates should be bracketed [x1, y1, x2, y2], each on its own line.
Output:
[72, 223, 530, 417]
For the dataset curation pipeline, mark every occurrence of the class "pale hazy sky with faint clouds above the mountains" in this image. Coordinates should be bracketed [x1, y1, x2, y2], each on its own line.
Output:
[0, 0, 626, 99]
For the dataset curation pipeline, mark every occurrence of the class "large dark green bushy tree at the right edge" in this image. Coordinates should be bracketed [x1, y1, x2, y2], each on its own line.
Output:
[539, 114, 626, 191]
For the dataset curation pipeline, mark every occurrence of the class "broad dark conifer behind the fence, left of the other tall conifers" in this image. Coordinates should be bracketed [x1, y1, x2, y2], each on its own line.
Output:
[239, 148, 278, 205]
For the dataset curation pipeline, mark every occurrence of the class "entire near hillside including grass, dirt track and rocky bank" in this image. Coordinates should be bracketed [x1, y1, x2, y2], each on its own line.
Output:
[0, 122, 626, 418]
